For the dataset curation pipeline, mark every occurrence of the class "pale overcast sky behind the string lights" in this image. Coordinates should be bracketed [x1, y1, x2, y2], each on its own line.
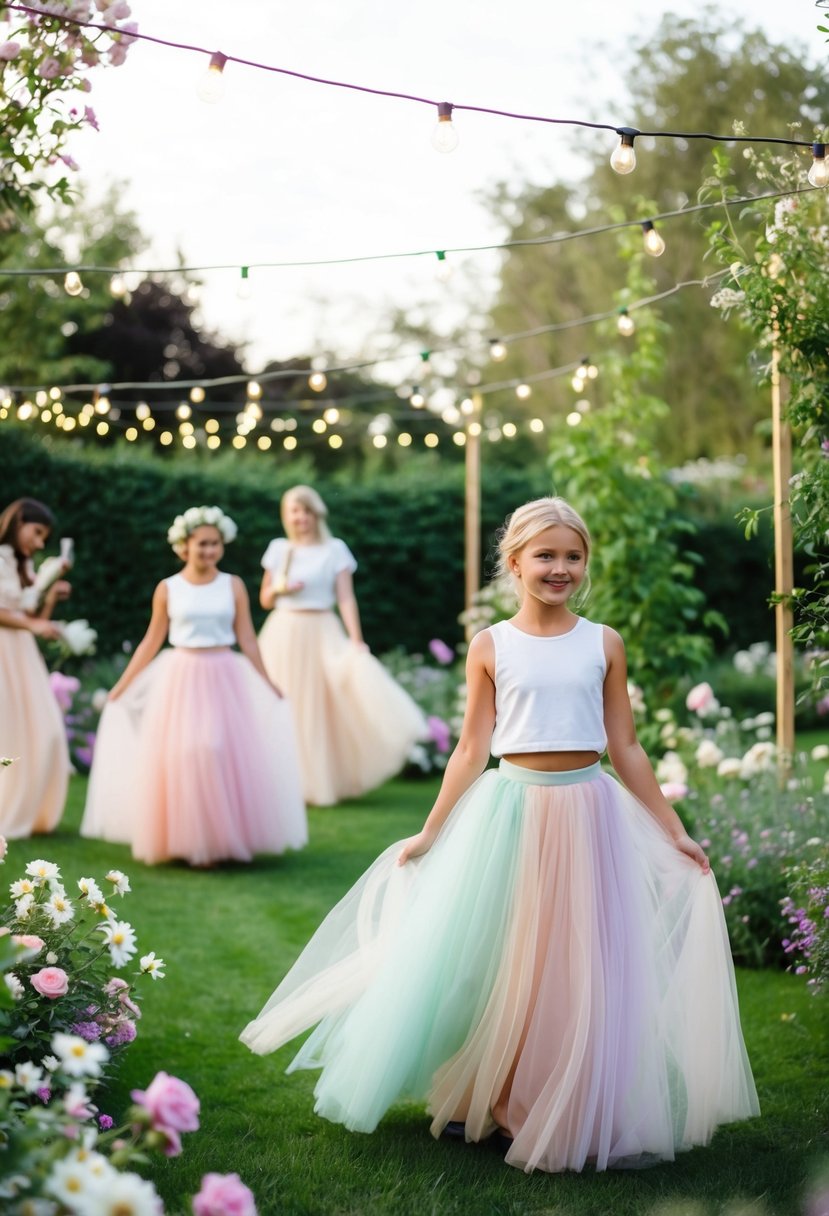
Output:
[71, 0, 827, 372]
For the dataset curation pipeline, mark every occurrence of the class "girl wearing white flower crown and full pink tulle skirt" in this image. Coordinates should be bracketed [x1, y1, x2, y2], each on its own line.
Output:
[80, 507, 308, 866]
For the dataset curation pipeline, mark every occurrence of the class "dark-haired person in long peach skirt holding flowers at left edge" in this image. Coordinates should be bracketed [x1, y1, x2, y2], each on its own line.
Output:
[0, 499, 71, 839]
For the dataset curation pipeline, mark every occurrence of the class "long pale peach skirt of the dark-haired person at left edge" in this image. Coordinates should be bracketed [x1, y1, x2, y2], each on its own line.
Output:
[0, 627, 69, 840]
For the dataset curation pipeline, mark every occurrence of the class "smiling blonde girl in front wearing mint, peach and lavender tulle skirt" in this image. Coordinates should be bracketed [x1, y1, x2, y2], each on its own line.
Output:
[242, 499, 758, 1171]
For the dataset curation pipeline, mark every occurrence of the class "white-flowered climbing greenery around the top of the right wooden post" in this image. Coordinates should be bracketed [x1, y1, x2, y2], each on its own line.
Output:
[704, 136, 829, 689]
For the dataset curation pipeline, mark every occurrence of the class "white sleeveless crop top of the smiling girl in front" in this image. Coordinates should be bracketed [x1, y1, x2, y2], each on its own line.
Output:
[490, 617, 608, 756]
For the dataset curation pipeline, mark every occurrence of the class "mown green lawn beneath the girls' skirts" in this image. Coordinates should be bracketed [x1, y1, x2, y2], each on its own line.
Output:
[16, 777, 829, 1216]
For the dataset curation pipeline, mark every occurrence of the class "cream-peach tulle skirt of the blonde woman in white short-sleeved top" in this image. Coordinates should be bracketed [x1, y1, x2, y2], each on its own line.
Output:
[259, 610, 428, 806]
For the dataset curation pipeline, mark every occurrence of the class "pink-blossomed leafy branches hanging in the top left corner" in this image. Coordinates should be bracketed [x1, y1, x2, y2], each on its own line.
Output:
[0, 0, 137, 216]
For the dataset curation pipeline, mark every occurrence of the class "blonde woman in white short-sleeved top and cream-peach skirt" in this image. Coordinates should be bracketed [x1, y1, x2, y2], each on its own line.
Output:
[259, 485, 428, 806]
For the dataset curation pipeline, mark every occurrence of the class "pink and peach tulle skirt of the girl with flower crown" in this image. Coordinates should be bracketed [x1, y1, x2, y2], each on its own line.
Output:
[80, 648, 308, 865]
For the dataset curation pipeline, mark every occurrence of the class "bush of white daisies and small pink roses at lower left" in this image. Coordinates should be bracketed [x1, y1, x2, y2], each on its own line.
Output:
[0, 838, 164, 1068]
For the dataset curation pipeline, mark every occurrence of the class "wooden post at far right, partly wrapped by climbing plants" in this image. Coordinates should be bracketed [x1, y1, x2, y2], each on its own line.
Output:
[772, 342, 795, 784]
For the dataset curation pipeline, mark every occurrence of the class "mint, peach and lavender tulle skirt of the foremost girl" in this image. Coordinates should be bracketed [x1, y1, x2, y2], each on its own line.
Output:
[241, 761, 758, 1172]
